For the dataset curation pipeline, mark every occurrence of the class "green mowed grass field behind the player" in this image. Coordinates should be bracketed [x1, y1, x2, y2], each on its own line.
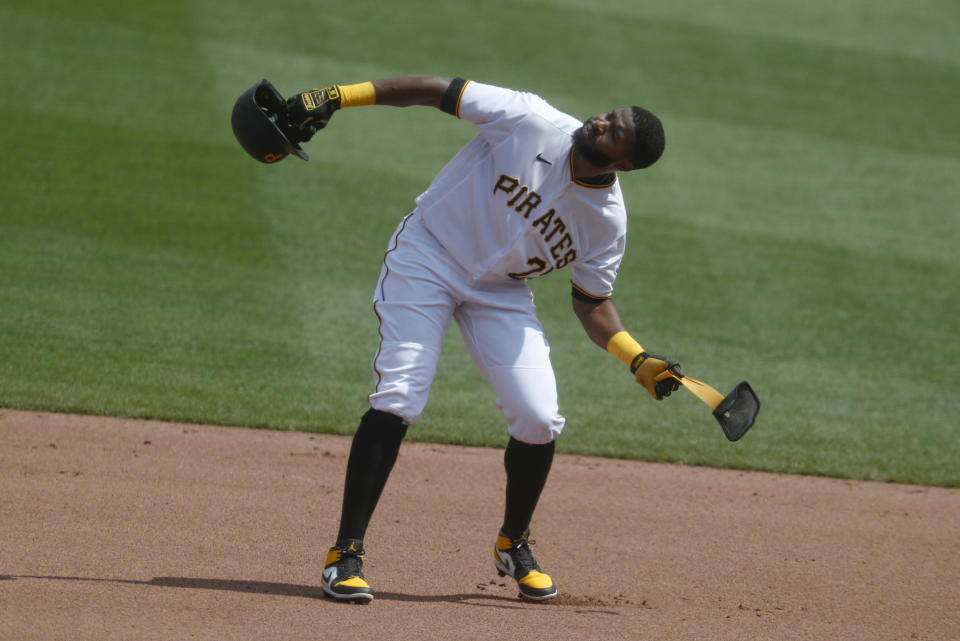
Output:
[0, 0, 960, 486]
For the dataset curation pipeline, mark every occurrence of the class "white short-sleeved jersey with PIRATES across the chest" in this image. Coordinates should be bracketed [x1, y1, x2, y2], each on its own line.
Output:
[417, 82, 627, 298]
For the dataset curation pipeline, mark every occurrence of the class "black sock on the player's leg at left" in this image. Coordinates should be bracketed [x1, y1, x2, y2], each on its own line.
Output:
[337, 409, 407, 543]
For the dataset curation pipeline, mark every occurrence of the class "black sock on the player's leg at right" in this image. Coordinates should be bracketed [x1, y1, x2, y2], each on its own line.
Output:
[501, 437, 556, 539]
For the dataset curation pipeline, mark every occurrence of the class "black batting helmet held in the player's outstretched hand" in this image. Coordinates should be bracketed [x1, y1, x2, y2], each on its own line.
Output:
[230, 78, 310, 163]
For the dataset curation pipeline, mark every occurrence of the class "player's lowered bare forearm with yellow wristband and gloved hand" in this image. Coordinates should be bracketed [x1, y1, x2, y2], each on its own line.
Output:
[573, 298, 681, 401]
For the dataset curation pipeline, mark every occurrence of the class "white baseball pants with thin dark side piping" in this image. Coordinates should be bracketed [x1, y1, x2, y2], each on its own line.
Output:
[370, 212, 564, 443]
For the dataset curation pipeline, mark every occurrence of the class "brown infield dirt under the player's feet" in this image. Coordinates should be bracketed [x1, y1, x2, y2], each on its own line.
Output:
[0, 410, 960, 641]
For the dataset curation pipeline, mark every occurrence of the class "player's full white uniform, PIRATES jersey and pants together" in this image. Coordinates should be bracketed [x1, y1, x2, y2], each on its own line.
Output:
[370, 82, 626, 443]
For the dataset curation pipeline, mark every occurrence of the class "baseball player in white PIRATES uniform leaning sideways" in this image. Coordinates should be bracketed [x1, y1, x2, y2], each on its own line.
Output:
[286, 76, 679, 602]
